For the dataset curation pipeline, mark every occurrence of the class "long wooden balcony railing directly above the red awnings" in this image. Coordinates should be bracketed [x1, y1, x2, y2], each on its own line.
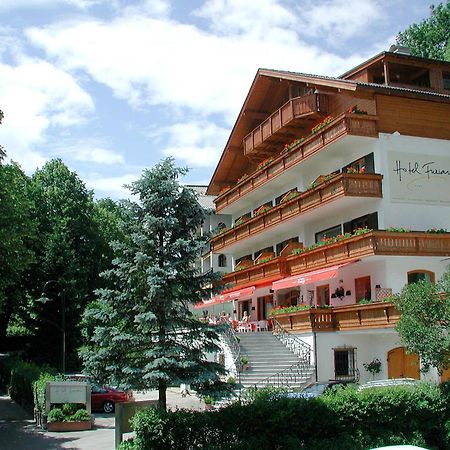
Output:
[223, 231, 450, 286]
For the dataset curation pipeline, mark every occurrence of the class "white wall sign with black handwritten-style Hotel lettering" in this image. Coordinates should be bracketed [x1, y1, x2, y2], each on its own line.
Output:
[388, 152, 450, 206]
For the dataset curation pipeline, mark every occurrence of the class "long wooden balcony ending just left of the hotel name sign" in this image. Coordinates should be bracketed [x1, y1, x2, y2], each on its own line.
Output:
[211, 173, 383, 251]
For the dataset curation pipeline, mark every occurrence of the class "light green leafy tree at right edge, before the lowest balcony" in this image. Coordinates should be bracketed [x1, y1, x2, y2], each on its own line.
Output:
[394, 270, 450, 372]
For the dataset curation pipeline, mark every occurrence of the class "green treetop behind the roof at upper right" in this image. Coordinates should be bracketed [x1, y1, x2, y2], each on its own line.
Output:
[397, 0, 450, 61]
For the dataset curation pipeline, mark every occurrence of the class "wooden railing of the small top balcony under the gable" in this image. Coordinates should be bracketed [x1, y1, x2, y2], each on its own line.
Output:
[243, 94, 328, 155]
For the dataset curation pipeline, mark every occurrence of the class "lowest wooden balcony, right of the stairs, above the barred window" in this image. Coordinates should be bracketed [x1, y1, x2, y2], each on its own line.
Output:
[274, 302, 400, 333]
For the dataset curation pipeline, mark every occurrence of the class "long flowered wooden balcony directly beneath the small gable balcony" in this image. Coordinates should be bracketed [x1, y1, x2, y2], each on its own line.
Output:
[214, 113, 378, 212]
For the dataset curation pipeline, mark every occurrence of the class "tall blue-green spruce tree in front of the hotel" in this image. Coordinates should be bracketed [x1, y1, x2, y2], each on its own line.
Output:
[82, 159, 224, 409]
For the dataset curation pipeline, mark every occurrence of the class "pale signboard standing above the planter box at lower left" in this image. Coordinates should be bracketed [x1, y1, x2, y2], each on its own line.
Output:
[45, 381, 91, 414]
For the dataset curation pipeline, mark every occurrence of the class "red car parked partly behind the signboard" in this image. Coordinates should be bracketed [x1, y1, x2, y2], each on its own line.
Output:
[64, 374, 134, 413]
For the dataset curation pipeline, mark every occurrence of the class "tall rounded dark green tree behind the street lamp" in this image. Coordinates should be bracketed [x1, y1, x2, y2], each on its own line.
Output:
[28, 159, 105, 365]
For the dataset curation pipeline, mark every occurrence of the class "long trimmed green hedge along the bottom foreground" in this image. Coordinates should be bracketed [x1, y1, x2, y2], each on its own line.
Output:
[123, 383, 450, 450]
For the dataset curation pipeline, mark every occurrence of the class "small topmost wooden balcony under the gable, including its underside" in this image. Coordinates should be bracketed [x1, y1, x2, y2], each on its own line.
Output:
[243, 94, 328, 156]
